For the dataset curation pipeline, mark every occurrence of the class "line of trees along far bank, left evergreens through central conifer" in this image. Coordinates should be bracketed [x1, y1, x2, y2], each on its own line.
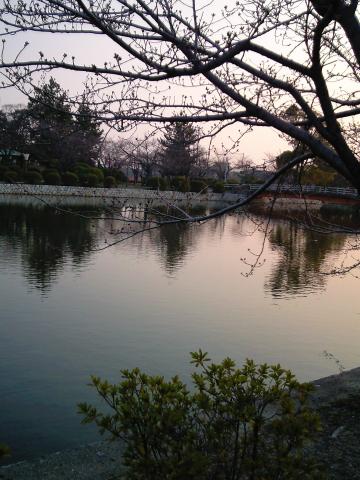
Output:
[0, 82, 253, 192]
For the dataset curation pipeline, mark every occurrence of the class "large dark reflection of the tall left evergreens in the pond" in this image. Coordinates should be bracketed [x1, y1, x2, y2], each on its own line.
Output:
[0, 205, 95, 292]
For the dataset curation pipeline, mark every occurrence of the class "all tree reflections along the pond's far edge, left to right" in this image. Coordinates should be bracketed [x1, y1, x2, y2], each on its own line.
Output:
[0, 197, 352, 296]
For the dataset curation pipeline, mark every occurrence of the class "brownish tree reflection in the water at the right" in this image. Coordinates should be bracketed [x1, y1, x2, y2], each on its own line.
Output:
[265, 223, 346, 297]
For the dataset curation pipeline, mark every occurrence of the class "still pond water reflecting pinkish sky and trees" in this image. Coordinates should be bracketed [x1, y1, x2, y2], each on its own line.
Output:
[0, 199, 360, 461]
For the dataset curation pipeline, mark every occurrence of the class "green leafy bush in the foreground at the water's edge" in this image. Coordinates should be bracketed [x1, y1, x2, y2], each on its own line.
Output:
[79, 350, 322, 480]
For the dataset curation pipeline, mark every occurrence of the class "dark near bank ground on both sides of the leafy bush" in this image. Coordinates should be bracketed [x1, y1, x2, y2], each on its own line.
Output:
[0, 367, 360, 480]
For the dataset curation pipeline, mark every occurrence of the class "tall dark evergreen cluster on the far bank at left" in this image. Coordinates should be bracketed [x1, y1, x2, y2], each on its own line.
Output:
[0, 78, 102, 171]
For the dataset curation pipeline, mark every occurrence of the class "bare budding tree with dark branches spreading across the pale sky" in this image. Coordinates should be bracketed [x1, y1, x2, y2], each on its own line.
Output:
[0, 0, 360, 216]
